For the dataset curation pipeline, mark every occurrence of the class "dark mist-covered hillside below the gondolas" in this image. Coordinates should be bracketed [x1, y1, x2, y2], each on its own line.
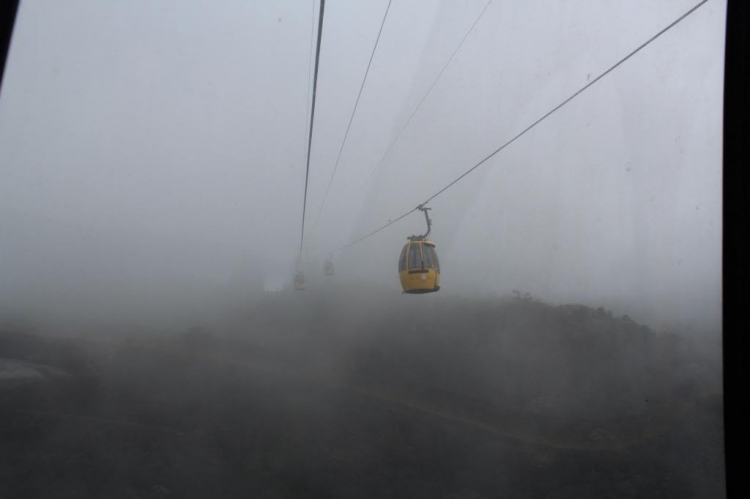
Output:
[0, 286, 724, 499]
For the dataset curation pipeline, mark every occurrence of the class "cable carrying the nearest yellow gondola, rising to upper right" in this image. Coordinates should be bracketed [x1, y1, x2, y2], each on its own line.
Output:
[333, 0, 708, 258]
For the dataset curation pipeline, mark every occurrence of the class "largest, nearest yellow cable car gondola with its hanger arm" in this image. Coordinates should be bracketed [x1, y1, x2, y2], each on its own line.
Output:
[398, 205, 440, 294]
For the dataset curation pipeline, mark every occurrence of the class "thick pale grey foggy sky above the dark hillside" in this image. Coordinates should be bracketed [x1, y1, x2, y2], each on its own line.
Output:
[0, 0, 726, 334]
